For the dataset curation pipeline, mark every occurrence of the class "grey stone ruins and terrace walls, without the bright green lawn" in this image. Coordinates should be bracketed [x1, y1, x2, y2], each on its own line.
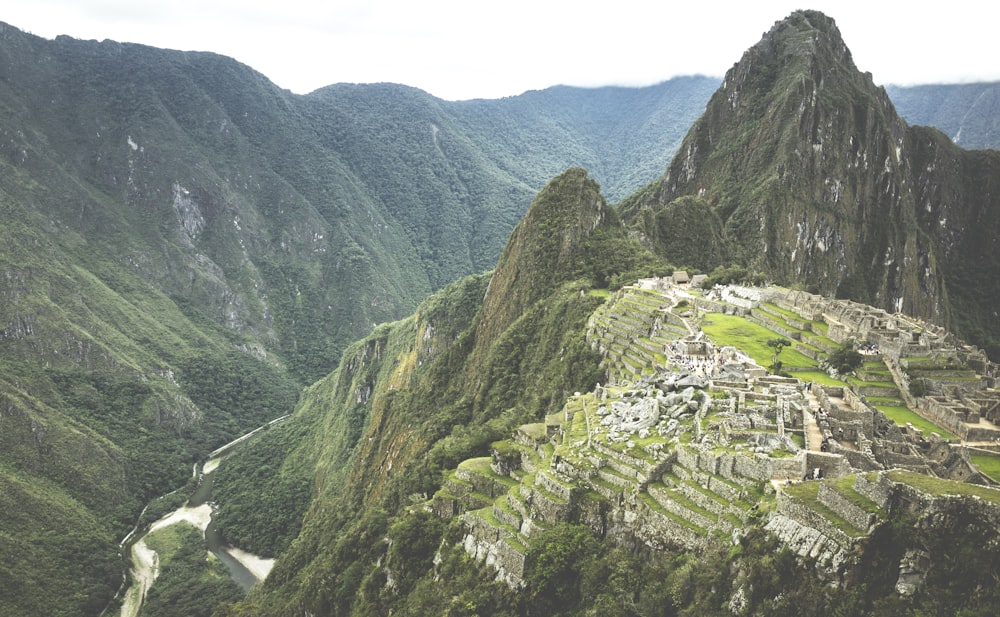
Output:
[448, 281, 1000, 594]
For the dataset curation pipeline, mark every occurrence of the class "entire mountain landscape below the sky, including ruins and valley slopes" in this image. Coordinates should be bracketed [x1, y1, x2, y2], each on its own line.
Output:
[0, 11, 1000, 617]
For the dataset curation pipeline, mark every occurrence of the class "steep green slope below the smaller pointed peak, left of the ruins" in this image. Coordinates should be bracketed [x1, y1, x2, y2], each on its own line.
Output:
[227, 169, 662, 614]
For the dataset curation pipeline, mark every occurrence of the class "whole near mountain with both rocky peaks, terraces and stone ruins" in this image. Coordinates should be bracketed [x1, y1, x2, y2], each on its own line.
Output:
[221, 12, 1000, 615]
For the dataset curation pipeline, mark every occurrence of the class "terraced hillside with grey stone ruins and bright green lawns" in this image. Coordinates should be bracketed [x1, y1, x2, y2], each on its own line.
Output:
[442, 280, 1000, 587]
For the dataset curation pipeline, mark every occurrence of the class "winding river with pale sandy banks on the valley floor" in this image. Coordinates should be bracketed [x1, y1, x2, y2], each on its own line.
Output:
[112, 415, 289, 617]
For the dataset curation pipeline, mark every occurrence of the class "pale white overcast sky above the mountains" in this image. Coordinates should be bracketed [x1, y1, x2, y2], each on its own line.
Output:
[0, 0, 1000, 100]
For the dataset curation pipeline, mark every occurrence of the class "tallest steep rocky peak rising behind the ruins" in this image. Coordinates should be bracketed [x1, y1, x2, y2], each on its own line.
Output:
[624, 11, 1000, 354]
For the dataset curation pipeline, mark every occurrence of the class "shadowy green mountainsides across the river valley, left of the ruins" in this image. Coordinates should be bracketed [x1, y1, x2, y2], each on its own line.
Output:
[0, 25, 713, 614]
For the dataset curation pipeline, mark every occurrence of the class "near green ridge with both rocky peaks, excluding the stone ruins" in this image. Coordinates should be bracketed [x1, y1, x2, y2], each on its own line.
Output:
[223, 12, 995, 615]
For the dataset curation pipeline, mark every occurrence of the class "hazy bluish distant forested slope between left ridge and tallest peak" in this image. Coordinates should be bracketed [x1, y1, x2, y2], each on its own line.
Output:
[448, 76, 719, 202]
